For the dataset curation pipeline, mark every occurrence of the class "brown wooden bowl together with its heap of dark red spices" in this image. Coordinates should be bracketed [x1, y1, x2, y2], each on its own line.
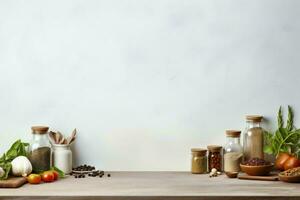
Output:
[240, 158, 274, 176]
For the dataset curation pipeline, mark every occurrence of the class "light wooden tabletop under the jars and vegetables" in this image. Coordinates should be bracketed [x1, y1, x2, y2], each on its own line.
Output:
[0, 172, 300, 200]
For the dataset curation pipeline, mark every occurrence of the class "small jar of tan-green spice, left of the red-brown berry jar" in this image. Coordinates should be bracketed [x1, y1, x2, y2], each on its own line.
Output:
[191, 148, 207, 174]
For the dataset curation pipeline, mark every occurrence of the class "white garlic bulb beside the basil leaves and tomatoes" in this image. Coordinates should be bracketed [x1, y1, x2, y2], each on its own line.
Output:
[11, 156, 32, 176]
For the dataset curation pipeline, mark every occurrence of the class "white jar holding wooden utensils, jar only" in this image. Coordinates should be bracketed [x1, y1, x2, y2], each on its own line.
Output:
[52, 144, 72, 174]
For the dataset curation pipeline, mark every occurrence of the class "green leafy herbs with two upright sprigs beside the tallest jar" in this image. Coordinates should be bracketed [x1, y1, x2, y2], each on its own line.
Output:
[264, 106, 300, 157]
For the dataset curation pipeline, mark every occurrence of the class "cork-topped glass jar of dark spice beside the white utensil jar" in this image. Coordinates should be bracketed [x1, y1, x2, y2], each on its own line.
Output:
[28, 126, 51, 173]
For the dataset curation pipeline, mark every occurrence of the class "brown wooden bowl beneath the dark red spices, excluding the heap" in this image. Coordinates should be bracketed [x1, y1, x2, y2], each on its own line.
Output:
[240, 164, 274, 176]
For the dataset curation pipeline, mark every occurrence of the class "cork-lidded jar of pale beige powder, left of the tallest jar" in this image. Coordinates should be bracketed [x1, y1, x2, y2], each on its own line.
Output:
[224, 130, 243, 172]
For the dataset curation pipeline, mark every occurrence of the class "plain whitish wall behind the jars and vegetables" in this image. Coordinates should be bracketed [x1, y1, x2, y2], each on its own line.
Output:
[0, 0, 300, 170]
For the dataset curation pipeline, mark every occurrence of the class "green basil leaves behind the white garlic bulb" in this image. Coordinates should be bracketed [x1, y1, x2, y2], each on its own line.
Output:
[0, 140, 29, 180]
